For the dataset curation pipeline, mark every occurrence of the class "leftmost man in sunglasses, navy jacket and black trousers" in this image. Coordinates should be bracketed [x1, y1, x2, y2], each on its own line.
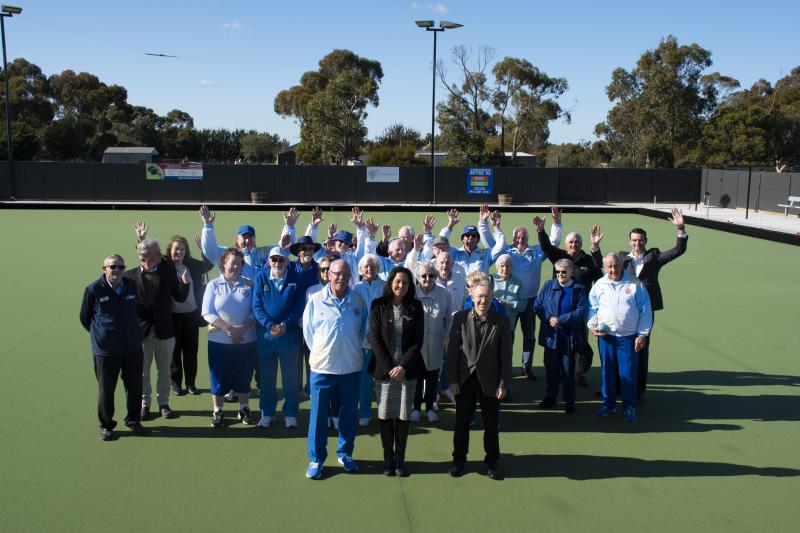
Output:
[80, 255, 145, 441]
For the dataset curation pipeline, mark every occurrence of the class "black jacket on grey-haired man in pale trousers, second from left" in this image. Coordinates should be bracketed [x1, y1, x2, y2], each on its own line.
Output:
[125, 258, 189, 340]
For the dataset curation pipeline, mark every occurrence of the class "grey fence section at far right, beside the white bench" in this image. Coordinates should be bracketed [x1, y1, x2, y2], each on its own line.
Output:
[702, 169, 800, 213]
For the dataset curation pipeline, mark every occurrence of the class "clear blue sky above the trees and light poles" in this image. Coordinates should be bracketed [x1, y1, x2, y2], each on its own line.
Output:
[6, 0, 800, 143]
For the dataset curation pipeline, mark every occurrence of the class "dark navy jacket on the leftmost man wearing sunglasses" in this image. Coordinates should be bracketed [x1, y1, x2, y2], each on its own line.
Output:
[80, 276, 142, 356]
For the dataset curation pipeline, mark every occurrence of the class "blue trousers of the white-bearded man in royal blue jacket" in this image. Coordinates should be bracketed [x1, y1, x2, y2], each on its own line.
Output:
[258, 327, 300, 417]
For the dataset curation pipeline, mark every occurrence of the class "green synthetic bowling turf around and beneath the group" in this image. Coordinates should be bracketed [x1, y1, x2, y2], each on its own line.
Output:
[0, 209, 800, 532]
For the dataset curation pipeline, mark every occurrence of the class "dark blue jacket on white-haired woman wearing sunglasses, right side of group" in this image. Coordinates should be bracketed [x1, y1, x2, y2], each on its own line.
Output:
[533, 279, 589, 352]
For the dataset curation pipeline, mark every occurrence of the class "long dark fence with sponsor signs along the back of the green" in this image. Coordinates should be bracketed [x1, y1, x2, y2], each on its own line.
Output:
[0, 162, 702, 205]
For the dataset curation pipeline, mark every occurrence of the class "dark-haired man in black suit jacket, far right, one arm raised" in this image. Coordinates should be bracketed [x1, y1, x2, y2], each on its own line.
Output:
[620, 207, 689, 403]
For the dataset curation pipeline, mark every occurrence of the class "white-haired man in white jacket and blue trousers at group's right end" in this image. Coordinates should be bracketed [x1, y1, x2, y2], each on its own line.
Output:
[587, 253, 653, 422]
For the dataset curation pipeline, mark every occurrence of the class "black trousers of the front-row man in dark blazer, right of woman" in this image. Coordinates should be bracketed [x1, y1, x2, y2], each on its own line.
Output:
[453, 372, 500, 466]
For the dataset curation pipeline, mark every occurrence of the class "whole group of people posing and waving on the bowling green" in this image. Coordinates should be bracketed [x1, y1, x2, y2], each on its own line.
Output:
[80, 205, 687, 479]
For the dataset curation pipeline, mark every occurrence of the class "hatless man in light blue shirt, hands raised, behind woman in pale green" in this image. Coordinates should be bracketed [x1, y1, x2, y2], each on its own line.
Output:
[485, 206, 561, 381]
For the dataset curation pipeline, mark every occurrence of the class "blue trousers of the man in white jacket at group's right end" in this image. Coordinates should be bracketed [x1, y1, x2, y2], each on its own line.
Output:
[597, 335, 639, 407]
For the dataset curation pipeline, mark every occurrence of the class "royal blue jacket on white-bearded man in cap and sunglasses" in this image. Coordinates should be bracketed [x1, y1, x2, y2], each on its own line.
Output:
[253, 268, 306, 338]
